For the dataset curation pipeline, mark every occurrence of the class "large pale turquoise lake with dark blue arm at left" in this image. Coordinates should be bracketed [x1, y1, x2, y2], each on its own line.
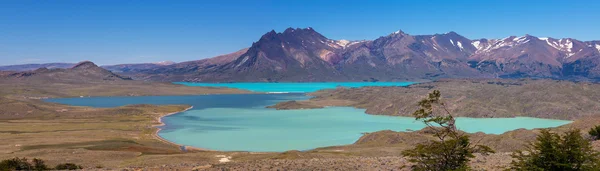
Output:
[47, 85, 570, 152]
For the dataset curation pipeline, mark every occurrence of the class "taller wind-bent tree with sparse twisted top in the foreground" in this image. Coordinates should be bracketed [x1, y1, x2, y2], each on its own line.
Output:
[402, 90, 494, 171]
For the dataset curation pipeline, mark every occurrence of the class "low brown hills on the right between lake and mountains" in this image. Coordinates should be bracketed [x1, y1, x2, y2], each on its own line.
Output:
[272, 79, 600, 120]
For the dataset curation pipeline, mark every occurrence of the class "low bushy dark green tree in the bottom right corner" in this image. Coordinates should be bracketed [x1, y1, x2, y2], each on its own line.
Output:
[511, 130, 600, 171]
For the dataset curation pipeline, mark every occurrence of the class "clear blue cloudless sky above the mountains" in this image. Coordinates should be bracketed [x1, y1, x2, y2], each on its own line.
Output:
[0, 0, 600, 65]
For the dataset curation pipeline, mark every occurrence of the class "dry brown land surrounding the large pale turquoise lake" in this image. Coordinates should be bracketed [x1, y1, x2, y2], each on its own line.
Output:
[0, 67, 600, 170]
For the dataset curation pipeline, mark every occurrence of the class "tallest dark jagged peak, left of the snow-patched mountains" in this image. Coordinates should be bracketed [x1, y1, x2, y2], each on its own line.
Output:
[198, 28, 346, 82]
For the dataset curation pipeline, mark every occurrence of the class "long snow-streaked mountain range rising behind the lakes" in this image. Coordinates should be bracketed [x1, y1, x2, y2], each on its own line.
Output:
[1, 28, 600, 82]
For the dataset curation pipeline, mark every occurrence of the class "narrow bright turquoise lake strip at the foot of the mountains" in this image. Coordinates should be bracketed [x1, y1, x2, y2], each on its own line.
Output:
[175, 82, 414, 93]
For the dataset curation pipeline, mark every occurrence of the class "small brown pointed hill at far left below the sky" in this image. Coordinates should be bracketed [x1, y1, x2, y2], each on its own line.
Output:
[0, 61, 131, 83]
